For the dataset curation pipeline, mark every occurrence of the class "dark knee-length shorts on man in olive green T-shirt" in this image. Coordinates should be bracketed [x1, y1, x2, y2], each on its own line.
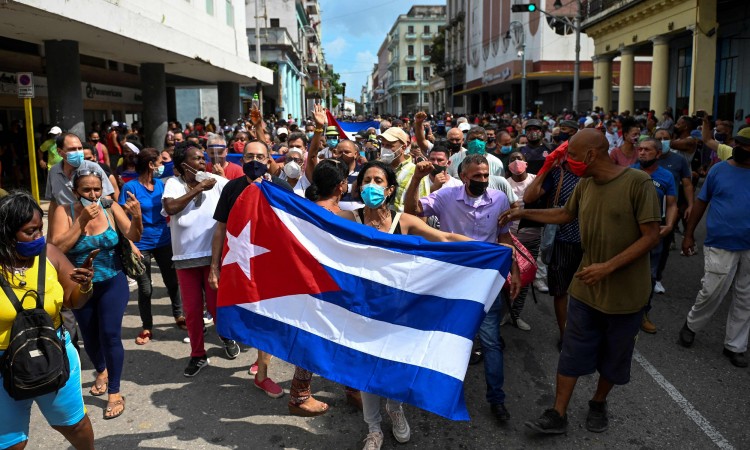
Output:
[557, 296, 643, 384]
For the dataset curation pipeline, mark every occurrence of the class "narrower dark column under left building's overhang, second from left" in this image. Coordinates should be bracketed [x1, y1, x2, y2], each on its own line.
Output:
[141, 63, 167, 151]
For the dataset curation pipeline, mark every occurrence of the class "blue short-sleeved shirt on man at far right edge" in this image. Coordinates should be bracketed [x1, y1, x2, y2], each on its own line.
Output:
[698, 161, 750, 252]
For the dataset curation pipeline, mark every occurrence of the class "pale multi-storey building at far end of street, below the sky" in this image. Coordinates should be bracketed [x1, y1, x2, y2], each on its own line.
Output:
[377, 5, 446, 115]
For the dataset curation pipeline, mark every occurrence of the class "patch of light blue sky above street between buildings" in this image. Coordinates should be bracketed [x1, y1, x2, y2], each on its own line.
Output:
[319, 0, 446, 99]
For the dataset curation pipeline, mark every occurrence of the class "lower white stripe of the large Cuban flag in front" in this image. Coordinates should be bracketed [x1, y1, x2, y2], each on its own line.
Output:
[237, 294, 472, 381]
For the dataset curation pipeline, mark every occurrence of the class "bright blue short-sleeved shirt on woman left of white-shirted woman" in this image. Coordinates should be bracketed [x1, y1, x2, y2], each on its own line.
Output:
[119, 178, 172, 250]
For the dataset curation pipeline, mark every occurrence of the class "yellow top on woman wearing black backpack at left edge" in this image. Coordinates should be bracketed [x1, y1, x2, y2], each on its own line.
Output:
[0, 256, 64, 353]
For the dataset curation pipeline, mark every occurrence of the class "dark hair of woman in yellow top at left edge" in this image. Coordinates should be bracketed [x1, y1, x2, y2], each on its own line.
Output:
[0, 191, 44, 276]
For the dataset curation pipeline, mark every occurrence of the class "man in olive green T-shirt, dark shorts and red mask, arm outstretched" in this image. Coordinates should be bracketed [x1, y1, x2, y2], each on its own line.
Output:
[501, 129, 661, 434]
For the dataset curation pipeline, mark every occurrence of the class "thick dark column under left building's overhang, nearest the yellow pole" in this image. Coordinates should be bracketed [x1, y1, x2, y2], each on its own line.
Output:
[44, 41, 86, 141]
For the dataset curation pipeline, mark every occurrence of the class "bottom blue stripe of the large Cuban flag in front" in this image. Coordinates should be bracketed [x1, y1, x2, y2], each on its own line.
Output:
[216, 306, 469, 420]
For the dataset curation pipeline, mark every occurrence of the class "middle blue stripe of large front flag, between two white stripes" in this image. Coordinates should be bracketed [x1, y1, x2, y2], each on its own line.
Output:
[322, 266, 484, 340]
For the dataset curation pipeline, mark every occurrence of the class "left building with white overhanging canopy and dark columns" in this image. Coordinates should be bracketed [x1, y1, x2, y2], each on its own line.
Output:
[0, 0, 273, 148]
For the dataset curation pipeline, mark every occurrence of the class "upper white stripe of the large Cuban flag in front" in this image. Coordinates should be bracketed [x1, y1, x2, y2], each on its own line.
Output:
[272, 206, 505, 312]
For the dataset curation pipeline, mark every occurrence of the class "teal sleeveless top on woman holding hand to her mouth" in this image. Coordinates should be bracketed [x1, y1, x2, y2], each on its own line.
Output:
[67, 204, 122, 283]
